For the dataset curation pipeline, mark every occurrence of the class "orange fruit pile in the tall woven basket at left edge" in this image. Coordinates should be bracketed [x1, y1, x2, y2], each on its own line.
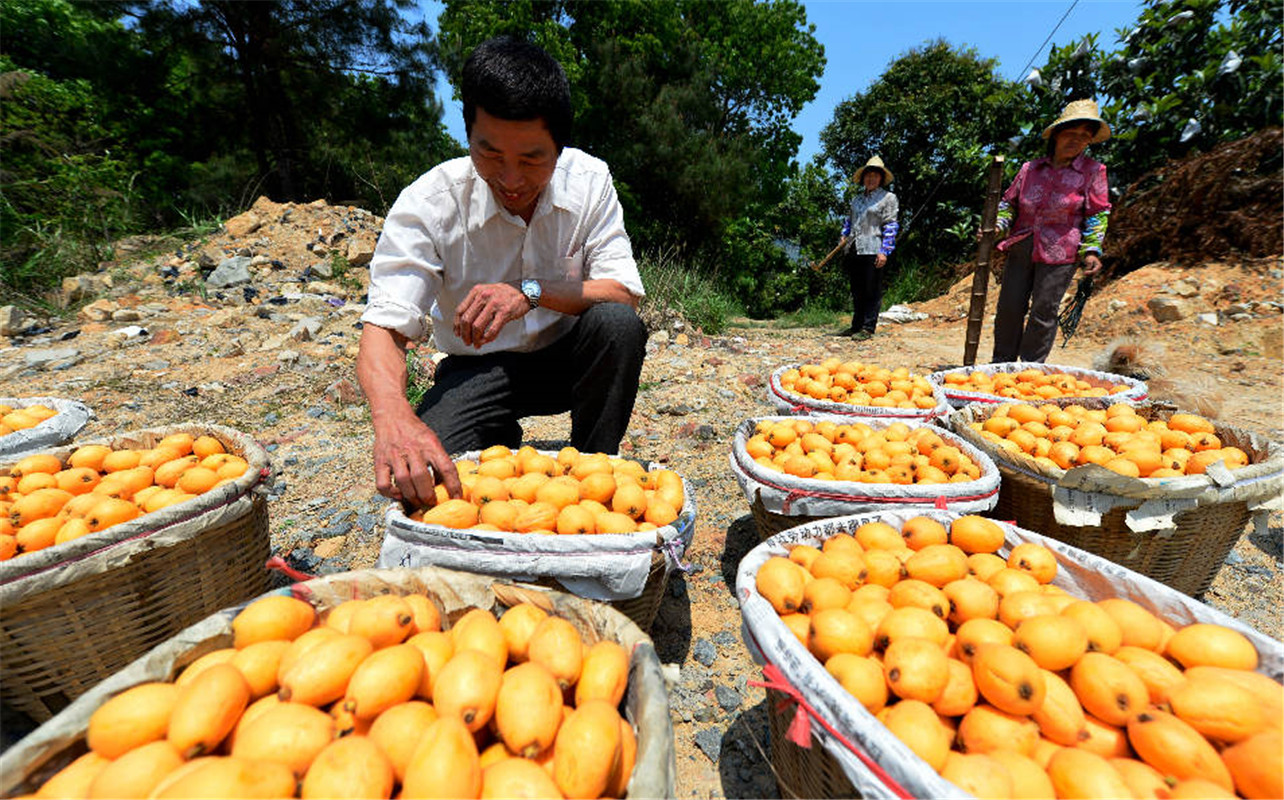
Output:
[0, 433, 249, 560]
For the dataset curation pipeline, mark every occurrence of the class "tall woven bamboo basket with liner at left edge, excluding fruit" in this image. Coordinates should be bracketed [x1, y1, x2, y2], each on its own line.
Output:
[0, 425, 270, 722]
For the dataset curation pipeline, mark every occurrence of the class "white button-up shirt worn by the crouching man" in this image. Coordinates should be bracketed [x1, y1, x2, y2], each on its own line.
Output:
[361, 148, 646, 356]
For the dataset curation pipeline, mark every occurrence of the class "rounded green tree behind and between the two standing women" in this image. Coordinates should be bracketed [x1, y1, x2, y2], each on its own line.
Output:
[820, 41, 1022, 270]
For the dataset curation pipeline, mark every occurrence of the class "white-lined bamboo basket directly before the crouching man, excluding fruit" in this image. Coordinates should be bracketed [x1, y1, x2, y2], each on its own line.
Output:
[379, 451, 696, 630]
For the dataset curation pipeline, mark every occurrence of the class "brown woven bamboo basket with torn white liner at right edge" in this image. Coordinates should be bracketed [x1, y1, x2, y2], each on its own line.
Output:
[946, 404, 1284, 597]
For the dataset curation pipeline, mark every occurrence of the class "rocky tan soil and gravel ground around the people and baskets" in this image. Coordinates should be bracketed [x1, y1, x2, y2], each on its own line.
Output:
[0, 200, 1284, 797]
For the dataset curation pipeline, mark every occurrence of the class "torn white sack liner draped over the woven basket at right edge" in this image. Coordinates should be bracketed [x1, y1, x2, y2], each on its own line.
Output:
[944, 398, 1284, 535]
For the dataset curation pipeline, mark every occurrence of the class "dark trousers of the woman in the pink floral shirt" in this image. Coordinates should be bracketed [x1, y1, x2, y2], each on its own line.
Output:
[991, 236, 1076, 363]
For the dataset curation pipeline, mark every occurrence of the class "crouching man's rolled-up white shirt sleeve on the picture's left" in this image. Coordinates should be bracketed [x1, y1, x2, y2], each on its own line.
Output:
[361, 186, 442, 339]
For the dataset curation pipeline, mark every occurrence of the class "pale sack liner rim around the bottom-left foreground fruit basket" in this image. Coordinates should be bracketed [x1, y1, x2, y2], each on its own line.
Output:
[0, 568, 677, 797]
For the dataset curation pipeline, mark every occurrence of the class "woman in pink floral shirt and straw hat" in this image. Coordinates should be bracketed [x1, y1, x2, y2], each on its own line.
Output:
[993, 100, 1111, 362]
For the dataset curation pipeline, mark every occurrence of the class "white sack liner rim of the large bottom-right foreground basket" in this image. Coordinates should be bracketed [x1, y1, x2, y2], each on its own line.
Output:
[736, 510, 1284, 799]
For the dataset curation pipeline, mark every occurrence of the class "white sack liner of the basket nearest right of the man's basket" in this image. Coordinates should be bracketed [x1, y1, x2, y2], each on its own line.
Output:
[731, 415, 999, 516]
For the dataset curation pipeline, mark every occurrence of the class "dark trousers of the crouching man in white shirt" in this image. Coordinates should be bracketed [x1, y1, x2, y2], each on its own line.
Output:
[417, 303, 647, 453]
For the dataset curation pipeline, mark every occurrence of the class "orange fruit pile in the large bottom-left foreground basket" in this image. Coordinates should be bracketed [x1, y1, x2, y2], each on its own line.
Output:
[37, 595, 637, 797]
